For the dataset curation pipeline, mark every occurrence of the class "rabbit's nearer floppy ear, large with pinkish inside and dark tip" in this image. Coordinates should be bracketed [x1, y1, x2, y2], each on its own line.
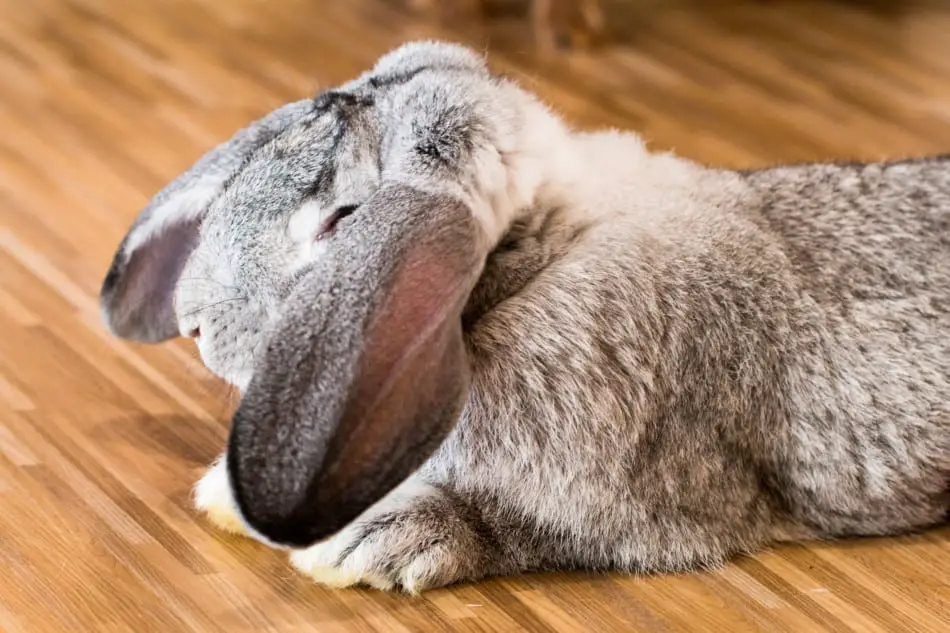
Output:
[227, 184, 485, 547]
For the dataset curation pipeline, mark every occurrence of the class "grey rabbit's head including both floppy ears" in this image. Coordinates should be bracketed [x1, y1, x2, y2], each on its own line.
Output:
[101, 42, 566, 546]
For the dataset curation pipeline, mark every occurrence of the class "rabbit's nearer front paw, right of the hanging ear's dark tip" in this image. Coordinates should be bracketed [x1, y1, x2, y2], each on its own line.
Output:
[290, 480, 486, 594]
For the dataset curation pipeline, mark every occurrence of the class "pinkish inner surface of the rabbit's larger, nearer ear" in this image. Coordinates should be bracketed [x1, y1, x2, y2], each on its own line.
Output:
[323, 241, 474, 494]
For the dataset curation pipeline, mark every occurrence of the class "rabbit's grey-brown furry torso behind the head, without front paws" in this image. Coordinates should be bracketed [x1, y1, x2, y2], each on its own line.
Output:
[421, 147, 950, 573]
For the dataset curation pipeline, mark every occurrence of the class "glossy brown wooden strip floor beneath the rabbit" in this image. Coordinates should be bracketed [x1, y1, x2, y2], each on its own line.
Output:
[0, 0, 950, 633]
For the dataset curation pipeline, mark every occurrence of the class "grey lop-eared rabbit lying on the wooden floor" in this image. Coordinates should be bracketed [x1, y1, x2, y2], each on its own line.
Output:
[101, 41, 950, 593]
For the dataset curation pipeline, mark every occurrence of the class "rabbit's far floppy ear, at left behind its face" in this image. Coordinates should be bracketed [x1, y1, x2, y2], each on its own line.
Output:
[99, 99, 313, 343]
